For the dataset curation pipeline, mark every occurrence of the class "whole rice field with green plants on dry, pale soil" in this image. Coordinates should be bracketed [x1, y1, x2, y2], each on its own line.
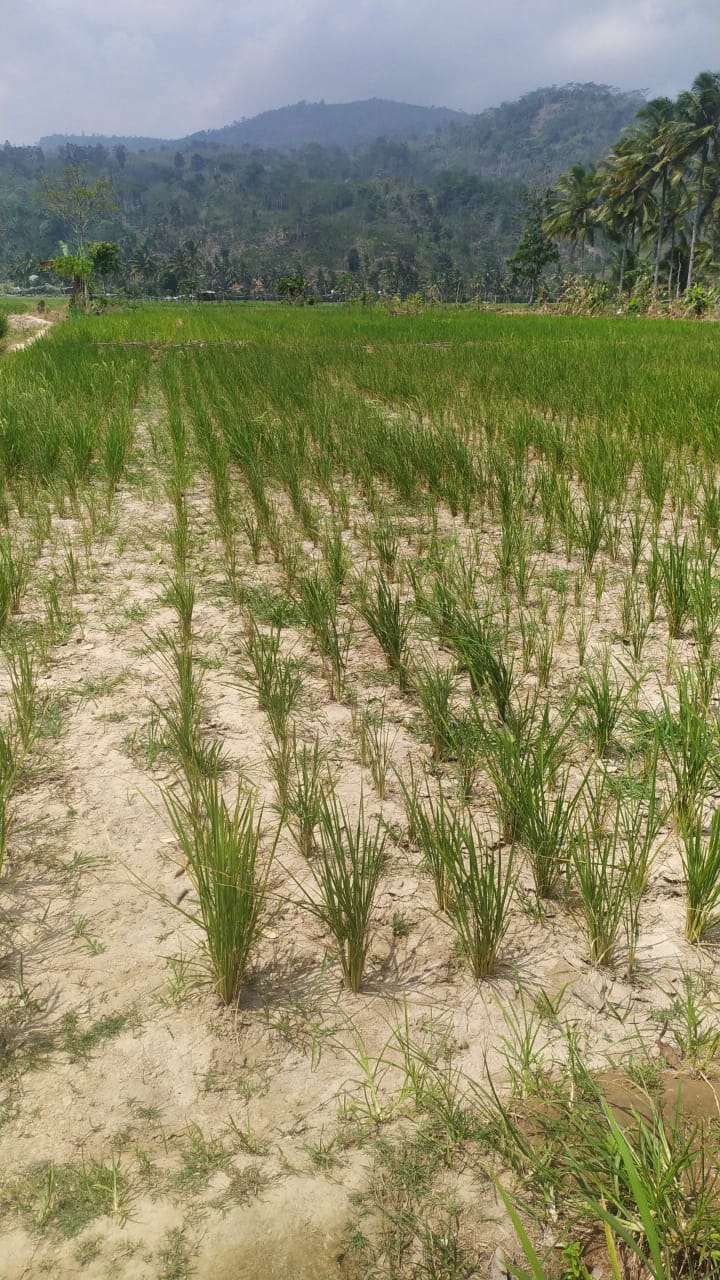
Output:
[0, 305, 720, 1280]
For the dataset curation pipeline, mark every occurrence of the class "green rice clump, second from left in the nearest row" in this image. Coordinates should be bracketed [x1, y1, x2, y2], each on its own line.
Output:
[305, 792, 387, 992]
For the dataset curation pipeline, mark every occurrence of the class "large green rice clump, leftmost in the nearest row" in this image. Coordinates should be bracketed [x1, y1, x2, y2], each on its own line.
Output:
[161, 773, 274, 1005]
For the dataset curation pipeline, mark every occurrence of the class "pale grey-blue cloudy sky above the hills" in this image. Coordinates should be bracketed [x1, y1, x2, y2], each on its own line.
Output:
[0, 0, 720, 145]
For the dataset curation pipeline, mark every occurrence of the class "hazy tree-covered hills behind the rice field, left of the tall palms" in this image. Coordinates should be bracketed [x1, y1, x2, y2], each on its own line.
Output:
[0, 84, 643, 298]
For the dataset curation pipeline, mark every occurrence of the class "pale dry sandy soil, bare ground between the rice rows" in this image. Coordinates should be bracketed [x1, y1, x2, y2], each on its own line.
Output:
[0, 389, 714, 1280]
